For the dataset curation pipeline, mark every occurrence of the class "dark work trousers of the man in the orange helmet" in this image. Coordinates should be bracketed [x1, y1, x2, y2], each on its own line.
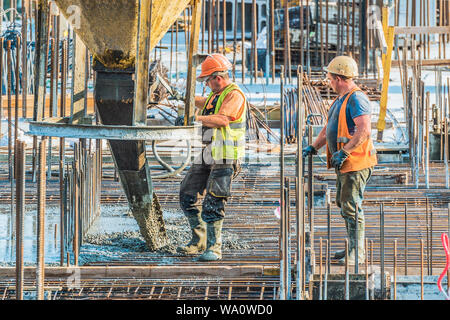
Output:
[180, 152, 239, 223]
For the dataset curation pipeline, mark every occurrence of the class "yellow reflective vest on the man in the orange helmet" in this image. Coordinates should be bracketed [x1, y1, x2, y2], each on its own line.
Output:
[203, 83, 247, 160]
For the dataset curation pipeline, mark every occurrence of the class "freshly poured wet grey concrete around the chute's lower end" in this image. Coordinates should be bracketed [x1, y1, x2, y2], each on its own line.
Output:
[0, 204, 251, 267]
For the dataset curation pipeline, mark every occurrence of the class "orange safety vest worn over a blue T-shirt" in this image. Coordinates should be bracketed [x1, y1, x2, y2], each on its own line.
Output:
[327, 87, 378, 173]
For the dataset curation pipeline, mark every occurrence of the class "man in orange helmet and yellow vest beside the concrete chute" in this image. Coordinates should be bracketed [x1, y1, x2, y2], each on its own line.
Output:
[177, 53, 247, 261]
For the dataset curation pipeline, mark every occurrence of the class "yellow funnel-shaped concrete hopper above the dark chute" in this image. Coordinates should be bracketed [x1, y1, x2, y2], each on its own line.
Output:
[55, 0, 191, 69]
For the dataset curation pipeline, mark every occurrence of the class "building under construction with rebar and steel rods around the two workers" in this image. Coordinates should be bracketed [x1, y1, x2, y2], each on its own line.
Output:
[0, 0, 450, 300]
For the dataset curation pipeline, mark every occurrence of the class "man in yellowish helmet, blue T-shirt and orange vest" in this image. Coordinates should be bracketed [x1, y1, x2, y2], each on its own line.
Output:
[303, 56, 377, 265]
